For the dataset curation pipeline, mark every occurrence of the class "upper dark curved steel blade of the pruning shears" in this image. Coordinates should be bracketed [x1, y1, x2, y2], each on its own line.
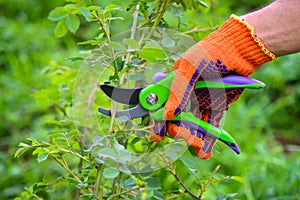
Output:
[100, 85, 144, 105]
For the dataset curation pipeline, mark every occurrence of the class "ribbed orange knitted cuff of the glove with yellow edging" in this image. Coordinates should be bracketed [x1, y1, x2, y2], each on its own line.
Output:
[200, 15, 275, 76]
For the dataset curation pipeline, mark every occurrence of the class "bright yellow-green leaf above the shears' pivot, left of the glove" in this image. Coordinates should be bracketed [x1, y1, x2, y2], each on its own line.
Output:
[139, 44, 167, 62]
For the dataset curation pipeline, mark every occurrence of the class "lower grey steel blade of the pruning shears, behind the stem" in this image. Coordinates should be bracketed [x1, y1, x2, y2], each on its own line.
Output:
[98, 104, 149, 119]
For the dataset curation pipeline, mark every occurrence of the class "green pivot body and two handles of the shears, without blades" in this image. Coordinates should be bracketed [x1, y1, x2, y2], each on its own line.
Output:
[139, 71, 265, 143]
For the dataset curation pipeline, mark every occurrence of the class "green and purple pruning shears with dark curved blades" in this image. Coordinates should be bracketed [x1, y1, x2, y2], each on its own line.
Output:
[98, 71, 265, 154]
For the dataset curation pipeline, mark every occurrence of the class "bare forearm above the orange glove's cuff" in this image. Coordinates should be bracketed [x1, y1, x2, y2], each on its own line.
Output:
[241, 0, 300, 56]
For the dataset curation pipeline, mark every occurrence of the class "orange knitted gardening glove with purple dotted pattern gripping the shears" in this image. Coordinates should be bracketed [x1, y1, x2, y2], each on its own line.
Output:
[151, 15, 275, 159]
